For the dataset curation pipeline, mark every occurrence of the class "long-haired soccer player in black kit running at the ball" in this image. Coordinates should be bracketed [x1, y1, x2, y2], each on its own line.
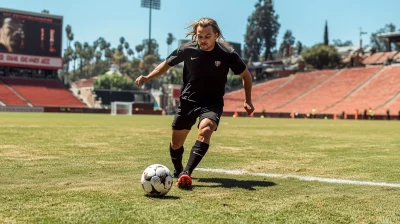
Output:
[136, 18, 254, 189]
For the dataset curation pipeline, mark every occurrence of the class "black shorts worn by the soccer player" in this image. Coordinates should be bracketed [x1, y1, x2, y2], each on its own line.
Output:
[172, 104, 223, 130]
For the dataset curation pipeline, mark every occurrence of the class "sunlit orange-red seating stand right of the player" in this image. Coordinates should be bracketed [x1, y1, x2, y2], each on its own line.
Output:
[224, 65, 400, 116]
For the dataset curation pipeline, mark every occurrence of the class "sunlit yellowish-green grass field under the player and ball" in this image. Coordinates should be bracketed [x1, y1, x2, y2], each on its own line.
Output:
[0, 113, 400, 224]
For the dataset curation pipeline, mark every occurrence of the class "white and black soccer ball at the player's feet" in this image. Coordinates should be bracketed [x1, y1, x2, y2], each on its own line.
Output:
[141, 164, 173, 196]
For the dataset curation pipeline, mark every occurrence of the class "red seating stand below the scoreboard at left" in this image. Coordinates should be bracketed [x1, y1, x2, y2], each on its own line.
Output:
[1, 77, 86, 107]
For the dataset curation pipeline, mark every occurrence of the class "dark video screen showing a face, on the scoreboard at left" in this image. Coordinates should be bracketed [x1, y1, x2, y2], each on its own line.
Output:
[0, 9, 62, 57]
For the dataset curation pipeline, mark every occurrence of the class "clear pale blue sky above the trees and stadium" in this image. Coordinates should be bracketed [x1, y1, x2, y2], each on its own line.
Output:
[1, 0, 400, 58]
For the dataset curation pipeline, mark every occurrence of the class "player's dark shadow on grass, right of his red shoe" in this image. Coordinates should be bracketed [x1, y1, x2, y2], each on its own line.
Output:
[195, 178, 276, 191]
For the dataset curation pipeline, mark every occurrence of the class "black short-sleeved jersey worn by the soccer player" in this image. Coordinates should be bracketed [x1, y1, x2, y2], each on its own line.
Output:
[166, 41, 246, 105]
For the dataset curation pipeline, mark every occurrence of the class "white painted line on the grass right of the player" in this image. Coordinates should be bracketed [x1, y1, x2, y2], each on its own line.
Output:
[196, 168, 400, 188]
